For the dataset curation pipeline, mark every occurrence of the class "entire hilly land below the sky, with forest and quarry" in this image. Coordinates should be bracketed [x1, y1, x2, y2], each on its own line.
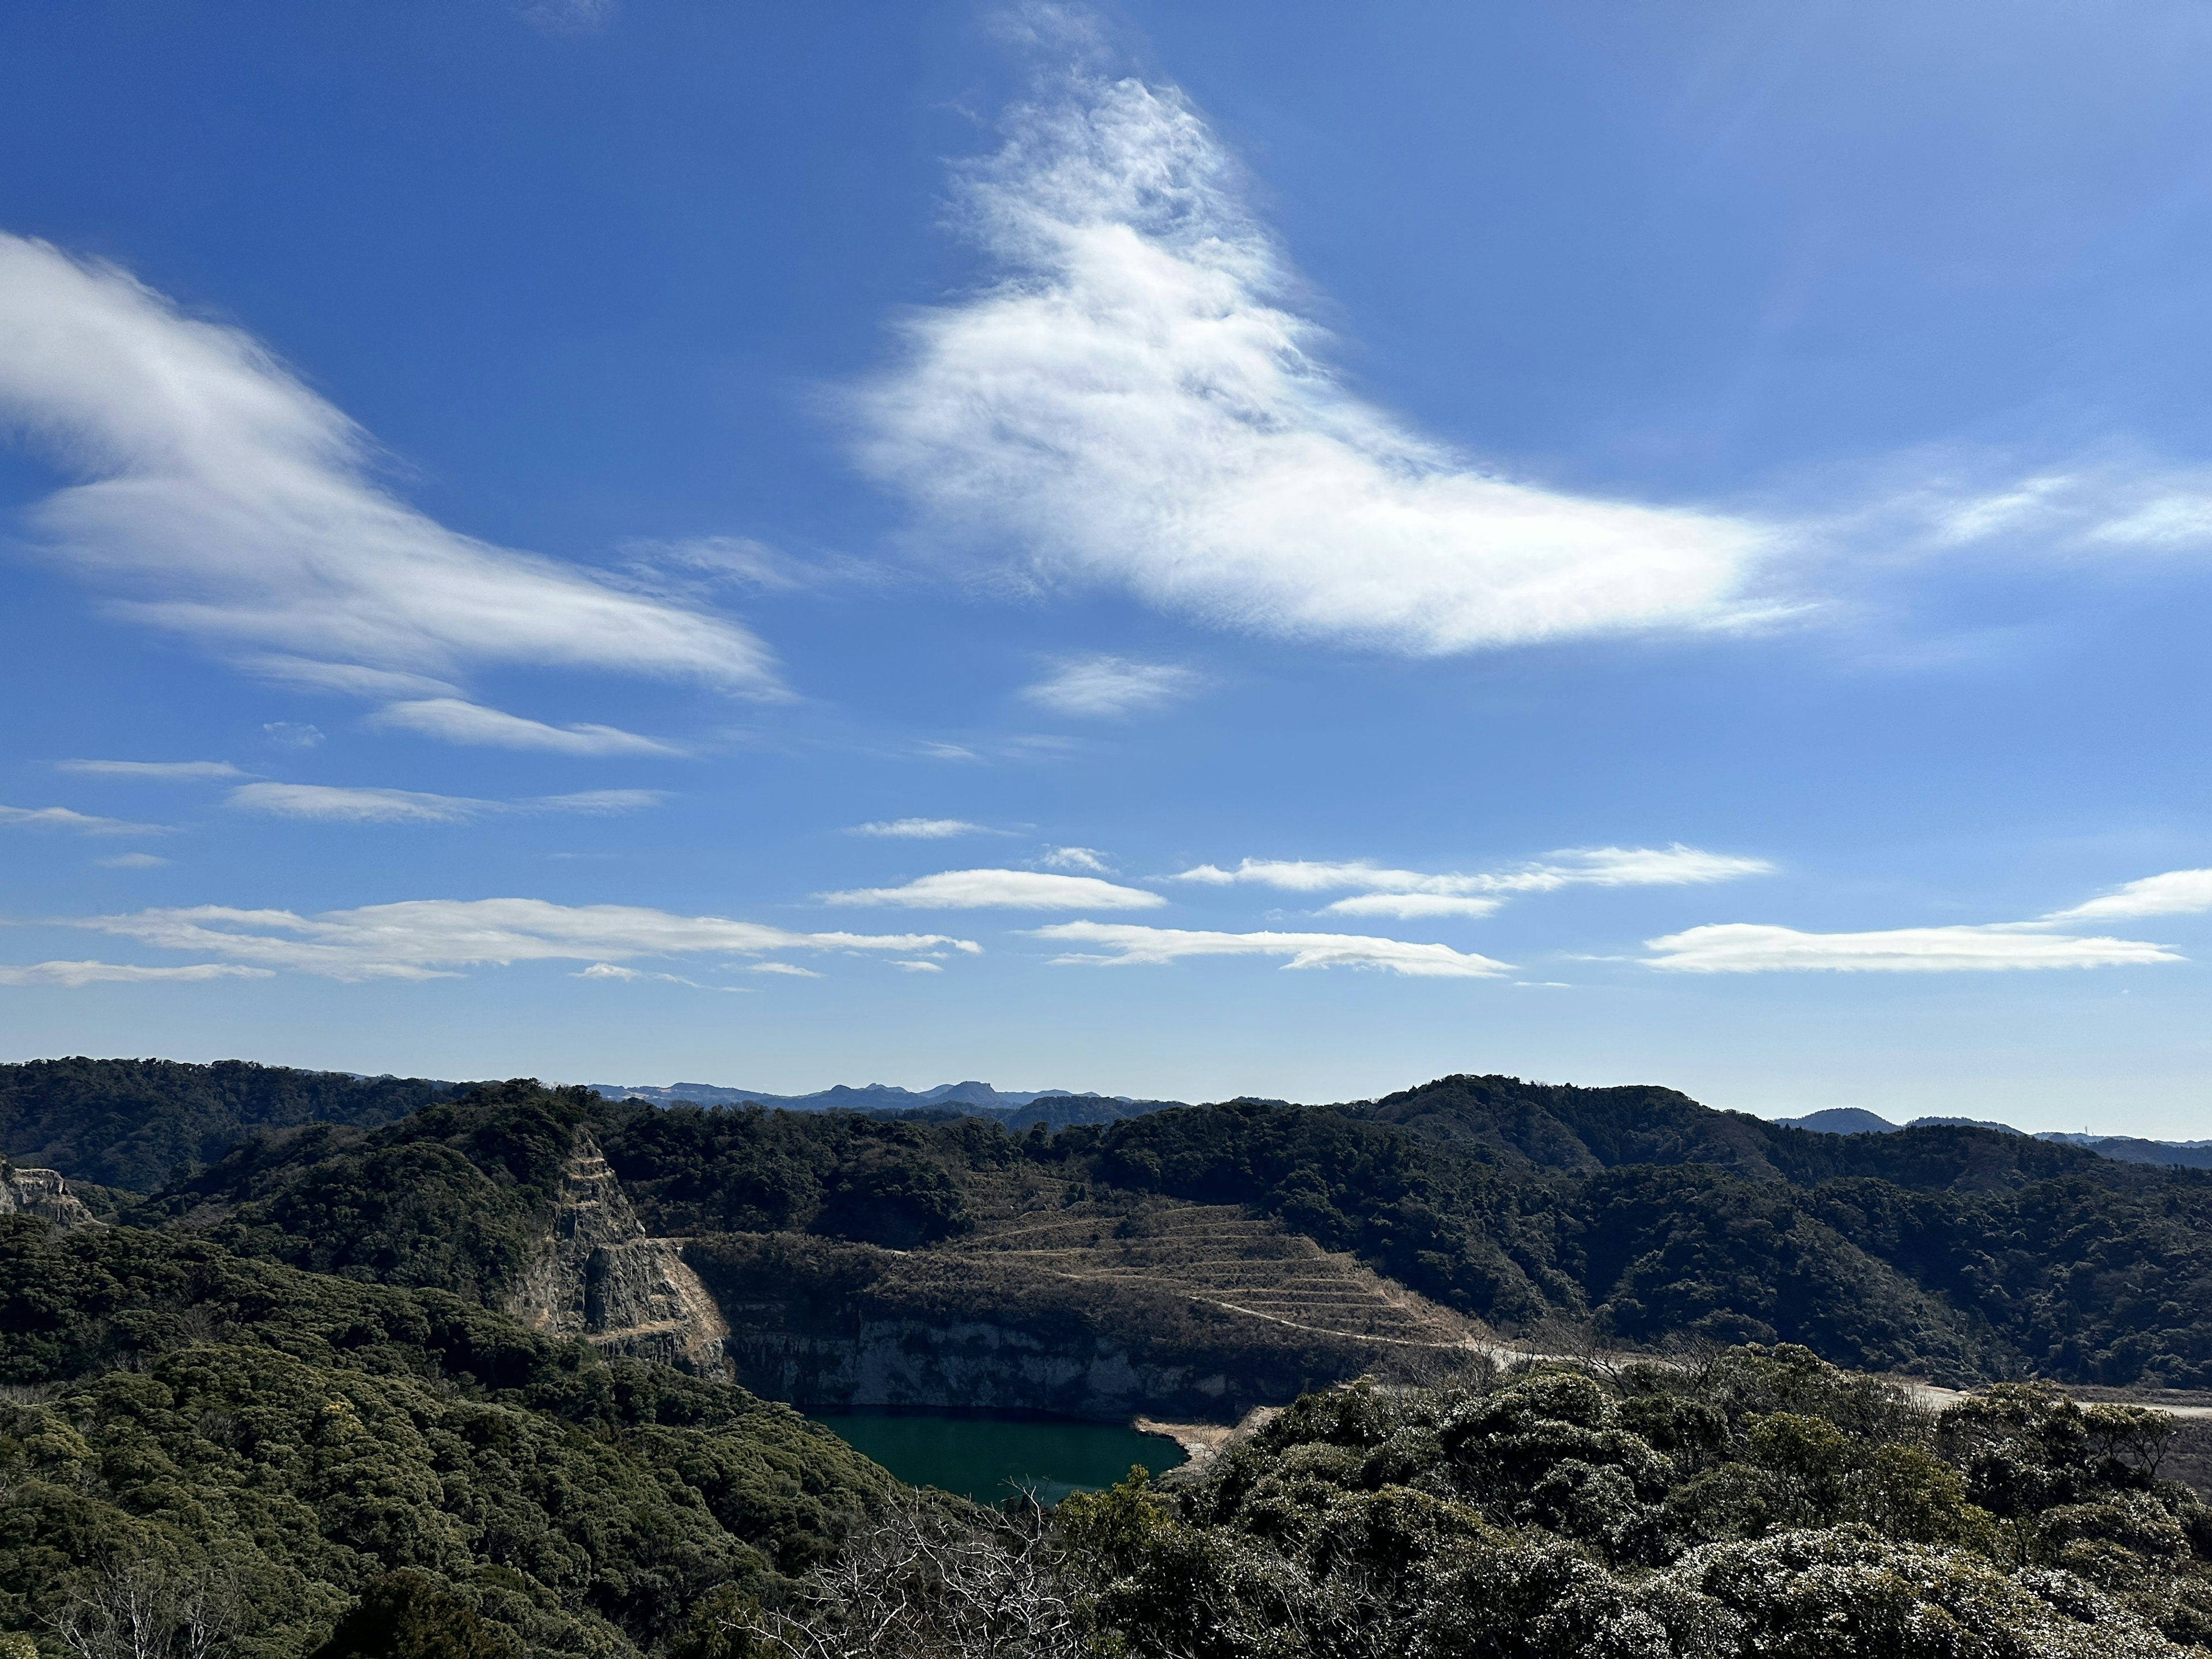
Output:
[0, 1062, 2212, 1659]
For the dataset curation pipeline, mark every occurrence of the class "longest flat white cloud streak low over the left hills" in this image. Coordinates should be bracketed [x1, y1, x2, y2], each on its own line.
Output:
[55, 898, 982, 980]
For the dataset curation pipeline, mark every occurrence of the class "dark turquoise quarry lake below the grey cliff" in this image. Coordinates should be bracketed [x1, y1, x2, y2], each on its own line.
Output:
[808, 1407, 1183, 1504]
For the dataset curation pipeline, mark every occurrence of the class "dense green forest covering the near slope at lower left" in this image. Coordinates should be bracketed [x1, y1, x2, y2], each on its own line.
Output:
[0, 1217, 892, 1659]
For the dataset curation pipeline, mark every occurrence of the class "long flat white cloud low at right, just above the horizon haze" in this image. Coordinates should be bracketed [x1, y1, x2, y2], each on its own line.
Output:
[1646, 922, 2183, 974]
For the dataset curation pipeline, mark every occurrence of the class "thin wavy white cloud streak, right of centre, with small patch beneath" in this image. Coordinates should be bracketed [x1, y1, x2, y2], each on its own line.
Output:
[1172, 843, 1774, 916]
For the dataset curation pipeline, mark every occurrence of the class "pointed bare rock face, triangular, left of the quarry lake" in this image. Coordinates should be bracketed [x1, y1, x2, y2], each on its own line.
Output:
[506, 1130, 728, 1376]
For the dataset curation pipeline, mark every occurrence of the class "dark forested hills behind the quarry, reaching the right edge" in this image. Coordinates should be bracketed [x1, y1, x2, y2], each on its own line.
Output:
[17, 1062, 2212, 1387]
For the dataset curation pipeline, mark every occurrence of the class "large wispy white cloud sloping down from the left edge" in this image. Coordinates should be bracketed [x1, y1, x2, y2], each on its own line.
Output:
[0, 234, 781, 695]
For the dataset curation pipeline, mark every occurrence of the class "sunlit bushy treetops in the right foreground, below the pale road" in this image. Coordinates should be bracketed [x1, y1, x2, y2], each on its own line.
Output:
[1022, 1347, 2212, 1659]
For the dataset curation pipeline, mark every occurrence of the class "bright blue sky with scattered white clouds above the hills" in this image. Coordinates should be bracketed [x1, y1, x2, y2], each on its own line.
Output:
[0, 0, 2212, 1135]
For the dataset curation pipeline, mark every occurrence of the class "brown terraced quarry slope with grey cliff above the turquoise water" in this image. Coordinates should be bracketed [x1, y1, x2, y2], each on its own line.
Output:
[684, 1172, 1484, 1422]
